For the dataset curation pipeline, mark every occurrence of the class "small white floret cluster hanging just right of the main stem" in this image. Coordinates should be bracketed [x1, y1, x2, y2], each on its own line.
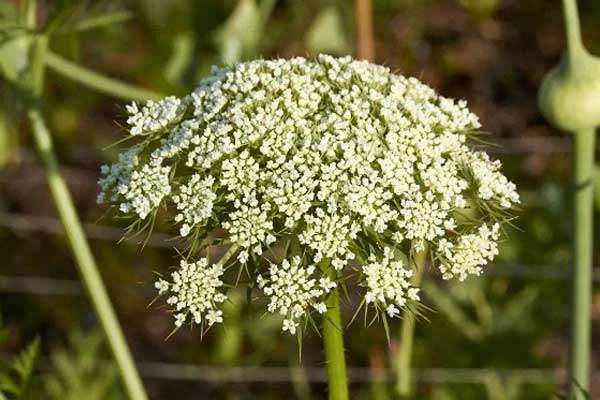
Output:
[362, 247, 419, 317]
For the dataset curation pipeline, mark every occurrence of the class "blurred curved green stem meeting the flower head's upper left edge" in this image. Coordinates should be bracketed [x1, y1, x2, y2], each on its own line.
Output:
[45, 51, 164, 100]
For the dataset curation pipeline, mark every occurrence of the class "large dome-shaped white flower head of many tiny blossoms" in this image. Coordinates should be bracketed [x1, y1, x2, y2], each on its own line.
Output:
[98, 55, 519, 331]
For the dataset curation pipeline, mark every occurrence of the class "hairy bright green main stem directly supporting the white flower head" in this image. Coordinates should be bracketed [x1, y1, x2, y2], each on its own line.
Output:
[319, 259, 349, 400]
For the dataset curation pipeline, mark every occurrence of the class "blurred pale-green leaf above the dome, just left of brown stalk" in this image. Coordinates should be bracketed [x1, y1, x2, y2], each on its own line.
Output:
[306, 7, 350, 54]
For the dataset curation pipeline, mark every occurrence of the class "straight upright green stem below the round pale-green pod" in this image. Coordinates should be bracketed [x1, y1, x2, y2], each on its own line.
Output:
[569, 129, 596, 400]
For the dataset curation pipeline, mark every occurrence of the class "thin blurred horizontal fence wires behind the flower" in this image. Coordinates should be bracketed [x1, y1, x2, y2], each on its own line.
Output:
[0, 137, 580, 385]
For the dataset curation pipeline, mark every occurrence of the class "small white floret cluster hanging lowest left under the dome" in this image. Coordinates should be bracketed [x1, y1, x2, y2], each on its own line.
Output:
[154, 258, 227, 328]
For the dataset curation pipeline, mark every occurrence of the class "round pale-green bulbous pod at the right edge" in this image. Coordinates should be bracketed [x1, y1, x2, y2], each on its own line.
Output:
[538, 49, 600, 132]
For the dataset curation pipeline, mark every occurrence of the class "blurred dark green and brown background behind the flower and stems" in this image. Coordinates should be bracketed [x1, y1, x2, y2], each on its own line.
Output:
[0, 0, 600, 400]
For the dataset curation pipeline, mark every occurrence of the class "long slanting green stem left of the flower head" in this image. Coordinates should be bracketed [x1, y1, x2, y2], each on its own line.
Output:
[27, 35, 147, 400]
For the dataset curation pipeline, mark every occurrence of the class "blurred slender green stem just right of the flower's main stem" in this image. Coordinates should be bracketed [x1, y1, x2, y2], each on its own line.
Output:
[394, 249, 427, 399]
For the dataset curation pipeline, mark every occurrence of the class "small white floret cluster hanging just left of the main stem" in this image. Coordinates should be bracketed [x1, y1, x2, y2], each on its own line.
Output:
[257, 256, 336, 335]
